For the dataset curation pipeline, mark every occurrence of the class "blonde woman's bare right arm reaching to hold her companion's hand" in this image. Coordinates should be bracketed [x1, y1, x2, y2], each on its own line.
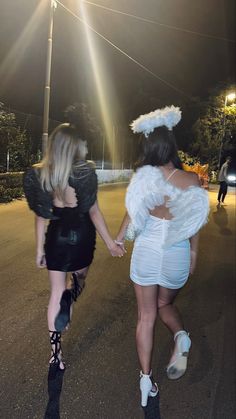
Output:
[89, 201, 124, 257]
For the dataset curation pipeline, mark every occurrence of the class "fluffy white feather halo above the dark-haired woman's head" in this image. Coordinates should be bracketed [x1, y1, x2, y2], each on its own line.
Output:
[130, 105, 181, 138]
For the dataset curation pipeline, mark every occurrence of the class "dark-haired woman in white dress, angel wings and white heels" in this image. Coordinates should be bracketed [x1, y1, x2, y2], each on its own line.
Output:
[116, 110, 208, 406]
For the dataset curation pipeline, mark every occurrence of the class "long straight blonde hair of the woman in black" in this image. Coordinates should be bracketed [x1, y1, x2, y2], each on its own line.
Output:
[36, 124, 87, 202]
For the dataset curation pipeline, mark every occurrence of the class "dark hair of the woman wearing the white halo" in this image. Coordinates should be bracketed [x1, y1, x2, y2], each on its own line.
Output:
[135, 126, 182, 169]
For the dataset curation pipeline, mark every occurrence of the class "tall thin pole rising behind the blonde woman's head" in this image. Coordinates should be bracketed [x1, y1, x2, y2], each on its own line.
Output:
[42, 0, 57, 154]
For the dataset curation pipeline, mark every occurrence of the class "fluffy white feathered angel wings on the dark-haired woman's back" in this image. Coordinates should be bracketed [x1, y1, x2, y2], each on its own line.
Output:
[126, 165, 209, 246]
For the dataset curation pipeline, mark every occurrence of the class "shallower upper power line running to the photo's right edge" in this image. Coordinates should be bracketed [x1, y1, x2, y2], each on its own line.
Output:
[83, 0, 236, 43]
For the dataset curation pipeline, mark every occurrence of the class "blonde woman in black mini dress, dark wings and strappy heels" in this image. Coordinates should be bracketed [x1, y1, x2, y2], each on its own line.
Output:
[24, 123, 124, 369]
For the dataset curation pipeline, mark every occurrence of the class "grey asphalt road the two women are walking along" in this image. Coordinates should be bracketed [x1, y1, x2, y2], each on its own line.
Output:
[0, 185, 236, 419]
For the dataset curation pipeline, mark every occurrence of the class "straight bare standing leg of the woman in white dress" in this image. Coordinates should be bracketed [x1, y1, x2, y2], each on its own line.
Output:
[134, 284, 158, 374]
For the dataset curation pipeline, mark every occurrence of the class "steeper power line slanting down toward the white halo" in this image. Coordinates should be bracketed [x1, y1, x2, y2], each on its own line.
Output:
[56, 0, 189, 98]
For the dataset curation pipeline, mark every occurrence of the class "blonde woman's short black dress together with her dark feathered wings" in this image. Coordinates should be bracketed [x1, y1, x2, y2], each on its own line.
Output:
[23, 162, 97, 272]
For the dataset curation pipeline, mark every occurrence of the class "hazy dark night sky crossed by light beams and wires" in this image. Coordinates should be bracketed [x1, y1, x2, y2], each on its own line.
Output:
[0, 0, 235, 124]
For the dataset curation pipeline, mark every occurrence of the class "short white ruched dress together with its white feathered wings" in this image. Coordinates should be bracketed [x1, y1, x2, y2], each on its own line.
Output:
[126, 165, 209, 289]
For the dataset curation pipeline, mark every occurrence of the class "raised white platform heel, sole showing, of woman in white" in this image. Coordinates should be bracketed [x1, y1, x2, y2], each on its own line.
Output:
[167, 330, 191, 380]
